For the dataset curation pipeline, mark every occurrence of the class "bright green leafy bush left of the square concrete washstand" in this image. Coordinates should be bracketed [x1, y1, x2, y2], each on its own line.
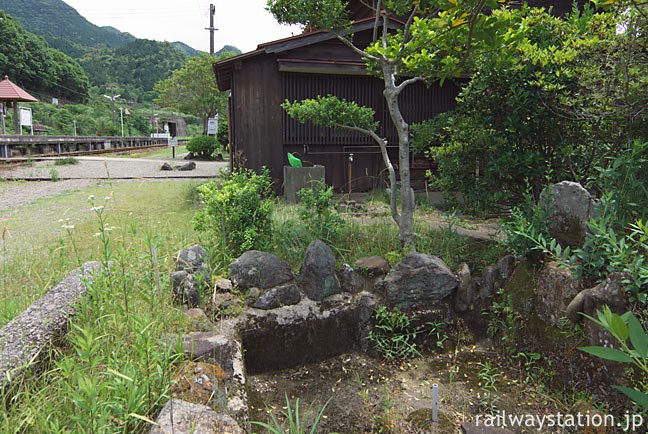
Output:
[194, 167, 274, 264]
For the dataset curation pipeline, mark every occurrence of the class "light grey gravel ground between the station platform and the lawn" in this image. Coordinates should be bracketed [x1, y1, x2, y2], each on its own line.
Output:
[0, 157, 228, 210]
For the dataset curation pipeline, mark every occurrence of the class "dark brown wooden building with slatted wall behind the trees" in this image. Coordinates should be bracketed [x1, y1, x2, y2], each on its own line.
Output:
[214, 0, 584, 191]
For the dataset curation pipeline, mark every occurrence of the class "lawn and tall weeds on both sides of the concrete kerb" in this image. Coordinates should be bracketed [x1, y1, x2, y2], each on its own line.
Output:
[0, 182, 210, 433]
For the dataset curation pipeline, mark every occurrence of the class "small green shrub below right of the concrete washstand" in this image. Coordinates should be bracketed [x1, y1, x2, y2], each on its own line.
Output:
[297, 181, 344, 244]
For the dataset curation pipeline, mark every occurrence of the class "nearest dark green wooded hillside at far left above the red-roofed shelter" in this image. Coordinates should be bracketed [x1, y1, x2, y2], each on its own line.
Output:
[0, 11, 89, 101]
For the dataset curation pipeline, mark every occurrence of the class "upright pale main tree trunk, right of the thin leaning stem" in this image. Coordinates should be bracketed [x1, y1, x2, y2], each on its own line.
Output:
[383, 64, 415, 251]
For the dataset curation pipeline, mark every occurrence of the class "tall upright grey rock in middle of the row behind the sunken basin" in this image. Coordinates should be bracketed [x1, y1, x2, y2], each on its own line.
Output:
[297, 240, 340, 301]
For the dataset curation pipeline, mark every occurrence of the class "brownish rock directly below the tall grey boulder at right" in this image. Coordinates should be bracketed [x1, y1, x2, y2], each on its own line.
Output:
[536, 262, 580, 326]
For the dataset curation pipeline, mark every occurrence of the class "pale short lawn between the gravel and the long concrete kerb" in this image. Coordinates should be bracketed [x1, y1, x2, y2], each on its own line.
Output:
[0, 182, 205, 325]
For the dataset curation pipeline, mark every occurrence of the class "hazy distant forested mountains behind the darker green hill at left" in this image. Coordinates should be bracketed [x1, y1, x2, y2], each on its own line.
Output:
[0, 0, 240, 102]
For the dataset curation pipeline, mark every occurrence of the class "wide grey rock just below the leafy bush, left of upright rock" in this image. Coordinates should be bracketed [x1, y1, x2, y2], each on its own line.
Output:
[229, 250, 295, 289]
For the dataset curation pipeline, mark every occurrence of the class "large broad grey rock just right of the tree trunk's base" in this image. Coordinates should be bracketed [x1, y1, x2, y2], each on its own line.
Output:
[383, 253, 457, 309]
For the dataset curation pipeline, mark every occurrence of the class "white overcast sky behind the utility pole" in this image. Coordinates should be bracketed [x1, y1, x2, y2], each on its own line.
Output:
[63, 0, 301, 52]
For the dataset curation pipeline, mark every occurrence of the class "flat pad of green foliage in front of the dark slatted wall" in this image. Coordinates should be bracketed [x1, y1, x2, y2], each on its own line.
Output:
[281, 95, 378, 131]
